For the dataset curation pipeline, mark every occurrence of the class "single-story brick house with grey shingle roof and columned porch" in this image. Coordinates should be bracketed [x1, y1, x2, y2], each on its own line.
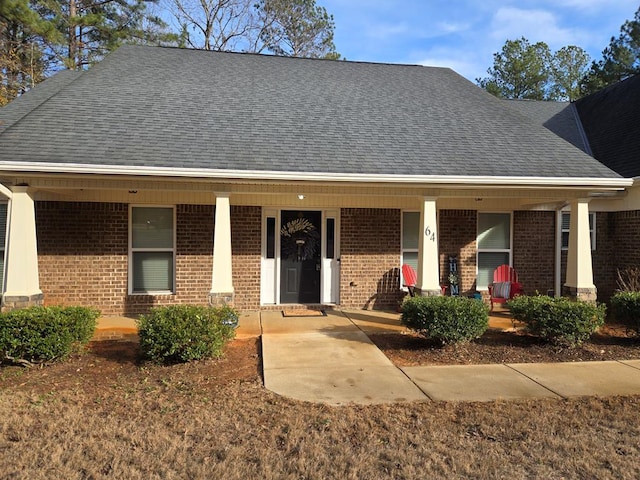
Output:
[0, 46, 639, 315]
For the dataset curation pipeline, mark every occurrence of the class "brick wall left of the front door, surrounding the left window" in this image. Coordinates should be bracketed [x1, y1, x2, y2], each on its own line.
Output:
[36, 202, 260, 315]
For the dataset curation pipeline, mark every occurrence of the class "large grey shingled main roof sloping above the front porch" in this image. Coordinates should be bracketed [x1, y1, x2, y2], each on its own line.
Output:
[0, 46, 619, 179]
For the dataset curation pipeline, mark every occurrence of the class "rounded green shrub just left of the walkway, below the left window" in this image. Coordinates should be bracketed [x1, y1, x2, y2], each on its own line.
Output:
[138, 305, 237, 363]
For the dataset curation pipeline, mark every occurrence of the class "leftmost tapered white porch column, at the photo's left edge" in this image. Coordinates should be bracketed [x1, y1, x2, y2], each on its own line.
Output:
[2, 187, 43, 310]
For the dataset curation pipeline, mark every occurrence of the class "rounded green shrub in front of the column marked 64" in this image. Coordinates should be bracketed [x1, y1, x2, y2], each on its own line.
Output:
[401, 296, 489, 344]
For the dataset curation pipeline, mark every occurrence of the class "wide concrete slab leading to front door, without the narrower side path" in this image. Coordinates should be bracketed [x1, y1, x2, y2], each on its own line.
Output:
[262, 311, 426, 405]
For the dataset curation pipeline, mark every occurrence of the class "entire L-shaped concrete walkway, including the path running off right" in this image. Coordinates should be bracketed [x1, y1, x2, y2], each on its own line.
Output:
[261, 311, 640, 405]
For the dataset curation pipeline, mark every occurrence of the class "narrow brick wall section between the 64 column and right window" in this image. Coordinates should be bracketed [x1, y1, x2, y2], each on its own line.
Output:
[438, 210, 478, 295]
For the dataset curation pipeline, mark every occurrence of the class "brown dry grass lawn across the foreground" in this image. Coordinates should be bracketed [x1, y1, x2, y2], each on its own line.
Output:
[0, 340, 640, 480]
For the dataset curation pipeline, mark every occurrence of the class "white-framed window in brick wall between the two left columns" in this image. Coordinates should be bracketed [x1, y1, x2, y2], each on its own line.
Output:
[129, 207, 175, 293]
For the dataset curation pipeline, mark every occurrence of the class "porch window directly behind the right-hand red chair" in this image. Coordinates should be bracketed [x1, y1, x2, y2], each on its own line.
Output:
[476, 213, 511, 290]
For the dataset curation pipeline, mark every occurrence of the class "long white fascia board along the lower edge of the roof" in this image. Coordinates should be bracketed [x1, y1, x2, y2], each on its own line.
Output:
[0, 162, 634, 189]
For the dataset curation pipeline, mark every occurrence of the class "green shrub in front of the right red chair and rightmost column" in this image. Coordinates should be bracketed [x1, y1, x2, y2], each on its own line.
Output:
[507, 295, 606, 347]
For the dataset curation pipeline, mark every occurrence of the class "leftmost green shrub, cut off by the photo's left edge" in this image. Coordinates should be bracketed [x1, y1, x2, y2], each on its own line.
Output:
[0, 307, 100, 362]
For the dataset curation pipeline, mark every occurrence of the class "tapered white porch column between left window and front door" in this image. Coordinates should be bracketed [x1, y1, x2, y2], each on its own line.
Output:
[209, 193, 234, 305]
